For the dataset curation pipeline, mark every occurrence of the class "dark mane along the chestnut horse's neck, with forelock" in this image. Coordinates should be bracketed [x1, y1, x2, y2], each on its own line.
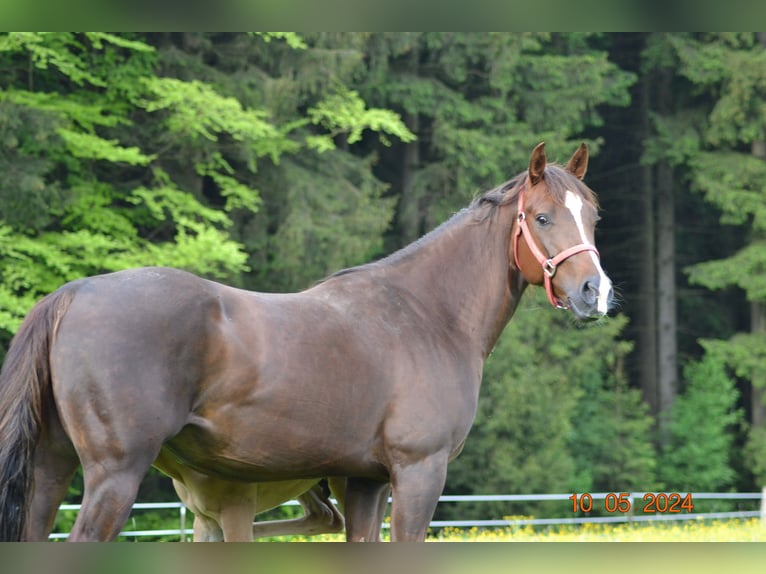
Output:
[317, 163, 598, 284]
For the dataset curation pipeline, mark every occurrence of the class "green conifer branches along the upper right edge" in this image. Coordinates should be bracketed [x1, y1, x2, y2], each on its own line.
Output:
[671, 34, 766, 301]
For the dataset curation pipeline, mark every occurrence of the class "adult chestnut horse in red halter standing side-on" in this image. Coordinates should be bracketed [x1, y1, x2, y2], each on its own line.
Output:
[0, 143, 613, 541]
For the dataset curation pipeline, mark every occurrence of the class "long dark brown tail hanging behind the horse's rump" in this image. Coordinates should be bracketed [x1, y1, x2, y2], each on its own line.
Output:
[0, 287, 75, 541]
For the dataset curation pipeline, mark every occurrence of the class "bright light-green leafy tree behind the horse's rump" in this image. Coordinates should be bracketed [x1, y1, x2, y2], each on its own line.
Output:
[0, 33, 266, 332]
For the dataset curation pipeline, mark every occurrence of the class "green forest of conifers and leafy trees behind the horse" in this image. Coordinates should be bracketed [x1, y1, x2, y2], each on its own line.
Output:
[0, 32, 766, 528]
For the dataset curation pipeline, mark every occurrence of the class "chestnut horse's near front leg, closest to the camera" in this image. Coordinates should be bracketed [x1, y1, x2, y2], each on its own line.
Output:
[391, 454, 448, 542]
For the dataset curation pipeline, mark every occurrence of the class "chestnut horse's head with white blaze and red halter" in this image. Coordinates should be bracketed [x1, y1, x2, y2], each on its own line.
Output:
[511, 143, 613, 319]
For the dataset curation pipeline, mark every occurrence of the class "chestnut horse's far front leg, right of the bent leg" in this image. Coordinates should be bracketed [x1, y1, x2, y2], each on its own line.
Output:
[344, 478, 391, 542]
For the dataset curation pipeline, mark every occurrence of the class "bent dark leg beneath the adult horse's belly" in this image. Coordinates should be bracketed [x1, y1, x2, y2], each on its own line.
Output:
[253, 483, 344, 538]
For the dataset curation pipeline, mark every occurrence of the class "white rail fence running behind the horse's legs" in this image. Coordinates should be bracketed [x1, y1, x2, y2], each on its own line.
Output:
[50, 488, 766, 541]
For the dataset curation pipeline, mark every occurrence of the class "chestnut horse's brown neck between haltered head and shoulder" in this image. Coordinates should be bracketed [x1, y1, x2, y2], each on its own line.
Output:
[390, 208, 526, 358]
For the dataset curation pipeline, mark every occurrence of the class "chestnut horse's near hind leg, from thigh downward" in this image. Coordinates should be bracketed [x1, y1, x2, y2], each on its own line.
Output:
[52, 364, 188, 542]
